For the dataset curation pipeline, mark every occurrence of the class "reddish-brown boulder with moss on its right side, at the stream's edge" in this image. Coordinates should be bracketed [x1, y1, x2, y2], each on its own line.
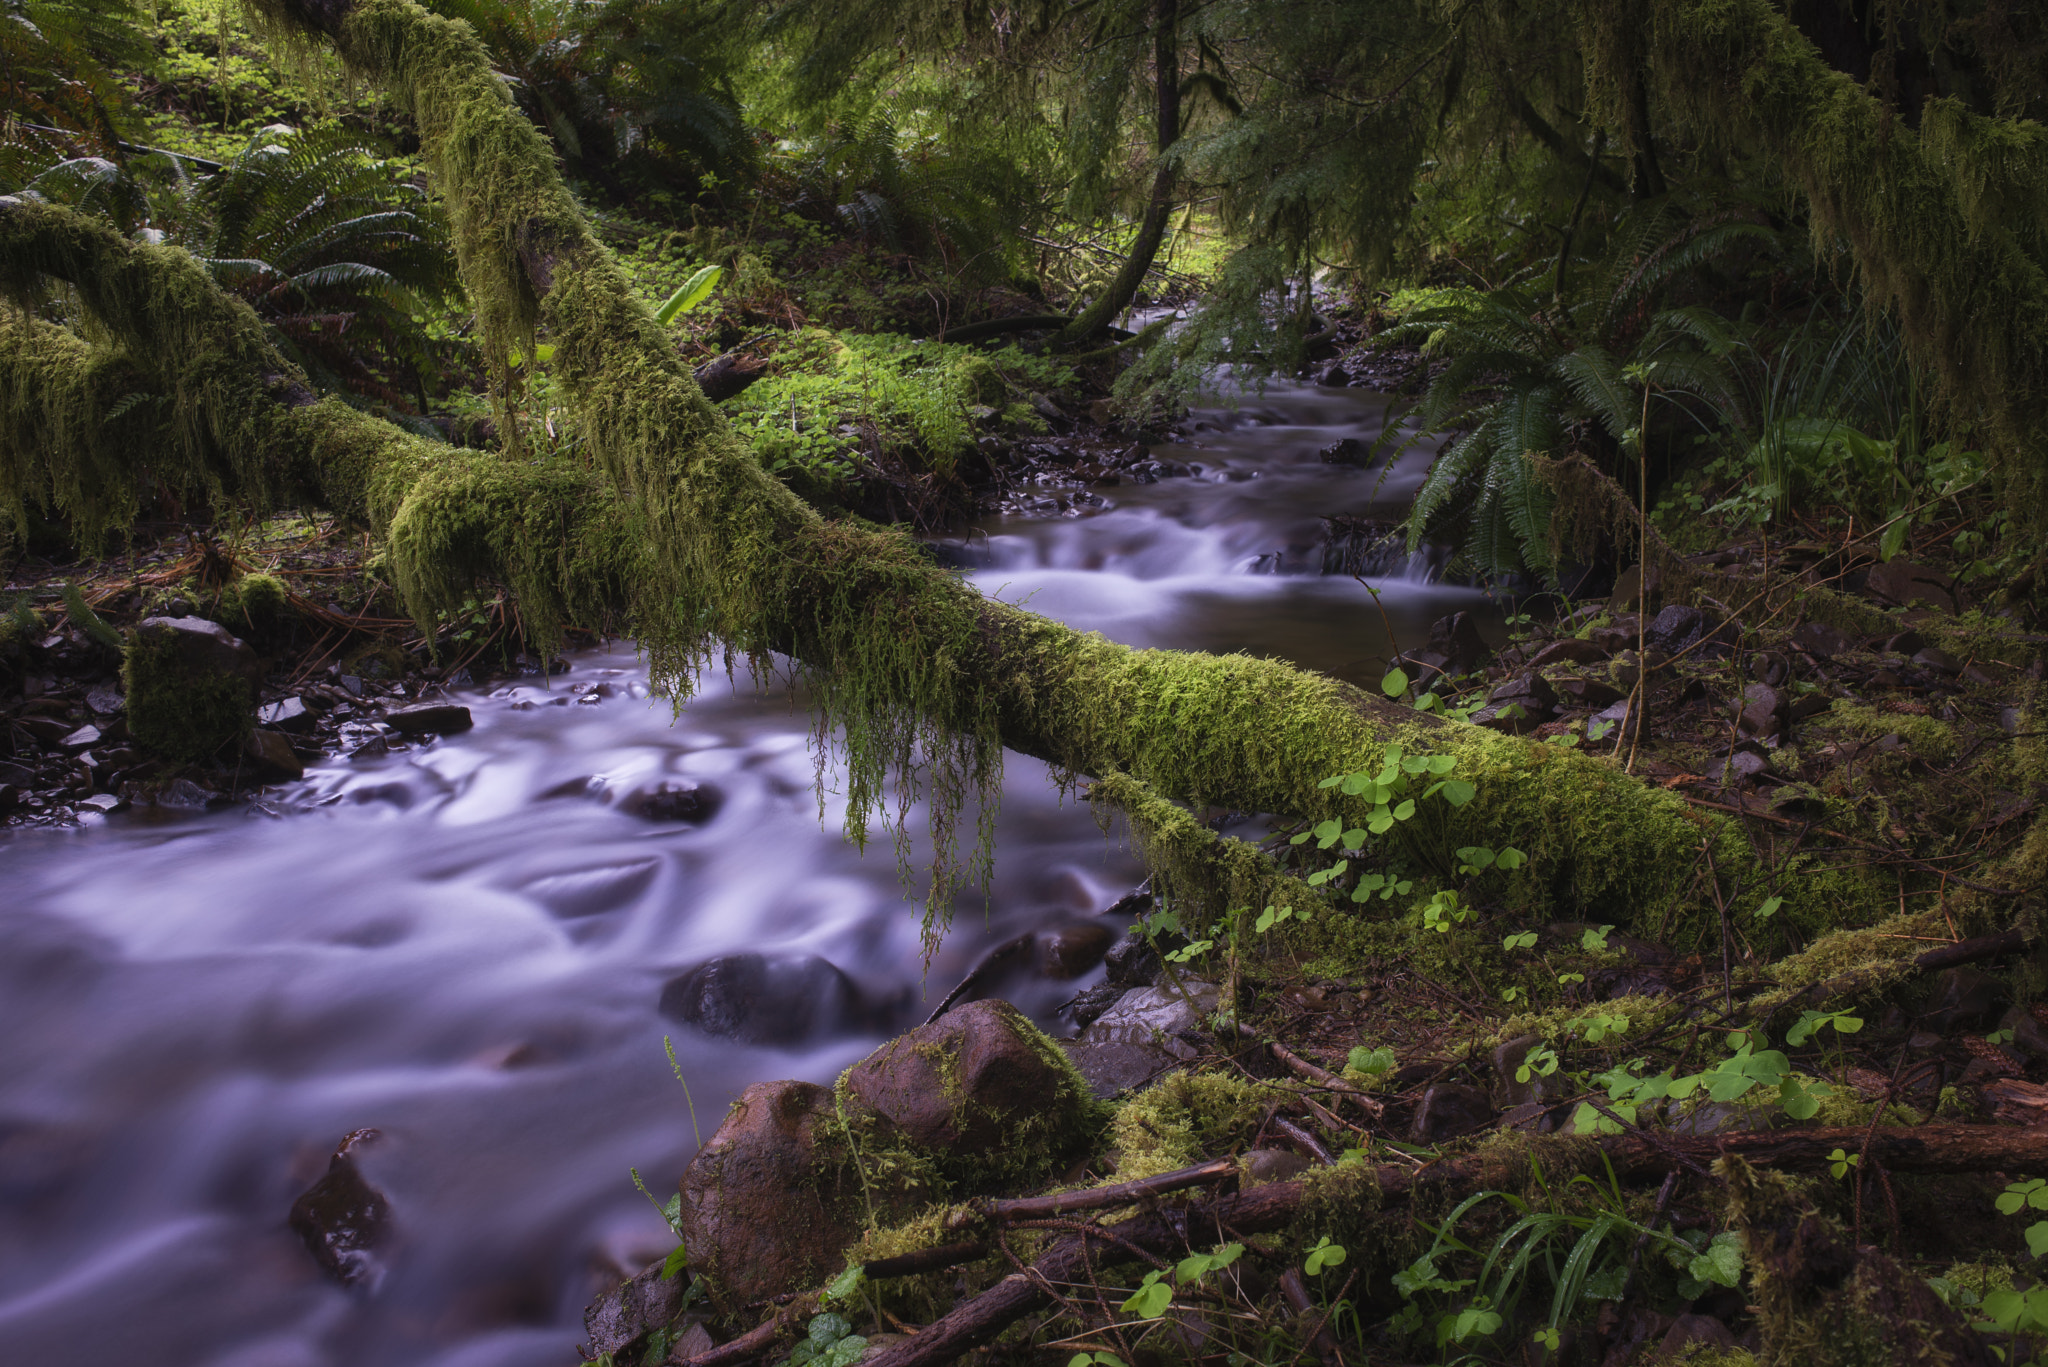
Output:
[846, 987, 1081, 1160]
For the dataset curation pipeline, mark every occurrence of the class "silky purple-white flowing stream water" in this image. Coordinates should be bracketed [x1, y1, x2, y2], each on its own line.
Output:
[0, 387, 1483, 1367]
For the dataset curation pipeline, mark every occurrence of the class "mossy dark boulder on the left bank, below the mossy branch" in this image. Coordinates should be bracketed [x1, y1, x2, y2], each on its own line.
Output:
[121, 617, 262, 760]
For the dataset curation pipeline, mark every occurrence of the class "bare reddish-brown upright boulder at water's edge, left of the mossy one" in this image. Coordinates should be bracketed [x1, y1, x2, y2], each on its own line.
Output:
[680, 1082, 860, 1314]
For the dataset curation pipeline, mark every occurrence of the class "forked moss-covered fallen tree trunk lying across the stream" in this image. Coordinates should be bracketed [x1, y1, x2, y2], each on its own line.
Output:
[0, 0, 1916, 959]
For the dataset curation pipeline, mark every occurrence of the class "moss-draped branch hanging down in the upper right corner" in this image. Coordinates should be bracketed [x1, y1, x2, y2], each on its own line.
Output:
[1579, 0, 2048, 537]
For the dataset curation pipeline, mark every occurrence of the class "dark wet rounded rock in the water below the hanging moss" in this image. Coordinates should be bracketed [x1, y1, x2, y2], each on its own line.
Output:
[659, 953, 860, 1045]
